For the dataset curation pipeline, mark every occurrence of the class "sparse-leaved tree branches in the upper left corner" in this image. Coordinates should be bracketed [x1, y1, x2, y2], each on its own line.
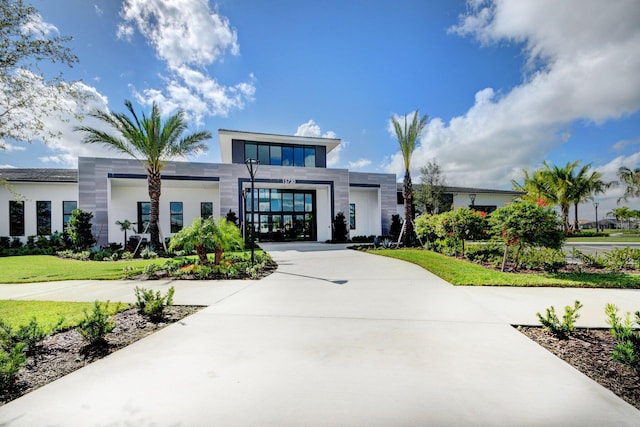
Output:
[0, 0, 81, 149]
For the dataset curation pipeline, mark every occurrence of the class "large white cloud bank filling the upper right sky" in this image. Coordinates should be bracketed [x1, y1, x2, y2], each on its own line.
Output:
[386, 0, 640, 187]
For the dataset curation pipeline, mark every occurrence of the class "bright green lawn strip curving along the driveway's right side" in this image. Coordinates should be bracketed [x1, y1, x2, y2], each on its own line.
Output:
[370, 249, 640, 289]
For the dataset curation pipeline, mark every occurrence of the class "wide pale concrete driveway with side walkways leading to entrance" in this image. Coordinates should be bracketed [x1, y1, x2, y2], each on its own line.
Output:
[0, 244, 640, 426]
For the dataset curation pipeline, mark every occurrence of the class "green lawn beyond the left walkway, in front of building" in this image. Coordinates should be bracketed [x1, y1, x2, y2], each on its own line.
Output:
[0, 255, 159, 283]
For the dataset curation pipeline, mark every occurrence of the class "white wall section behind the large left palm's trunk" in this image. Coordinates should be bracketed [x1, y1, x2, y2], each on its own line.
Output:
[109, 180, 221, 243]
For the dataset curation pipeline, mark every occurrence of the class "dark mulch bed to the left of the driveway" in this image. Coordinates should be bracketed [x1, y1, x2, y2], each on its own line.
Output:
[0, 306, 204, 405]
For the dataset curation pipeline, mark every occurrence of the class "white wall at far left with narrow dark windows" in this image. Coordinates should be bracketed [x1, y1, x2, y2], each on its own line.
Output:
[0, 182, 78, 242]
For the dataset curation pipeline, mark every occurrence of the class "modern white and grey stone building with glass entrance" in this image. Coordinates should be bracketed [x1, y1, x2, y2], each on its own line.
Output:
[0, 129, 517, 245]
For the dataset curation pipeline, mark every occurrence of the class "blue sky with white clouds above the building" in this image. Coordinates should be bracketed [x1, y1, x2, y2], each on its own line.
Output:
[0, 0, 640, 216]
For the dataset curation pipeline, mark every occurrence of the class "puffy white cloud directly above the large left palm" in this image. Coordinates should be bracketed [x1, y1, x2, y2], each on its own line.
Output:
[117, 0, 255, 123]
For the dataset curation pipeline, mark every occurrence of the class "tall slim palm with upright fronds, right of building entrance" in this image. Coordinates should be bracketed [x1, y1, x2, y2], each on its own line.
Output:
[391, 111, 427, 246]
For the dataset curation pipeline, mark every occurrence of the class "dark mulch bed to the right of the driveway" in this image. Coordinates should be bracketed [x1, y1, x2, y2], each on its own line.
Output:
[517, 326, 640, 409]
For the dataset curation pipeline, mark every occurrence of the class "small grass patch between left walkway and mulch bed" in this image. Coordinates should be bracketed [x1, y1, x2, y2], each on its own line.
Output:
[0, 300, 130, 332]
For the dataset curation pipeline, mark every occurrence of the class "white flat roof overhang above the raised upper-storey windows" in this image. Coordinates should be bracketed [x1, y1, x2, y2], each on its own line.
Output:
[218, 129, 340, 163]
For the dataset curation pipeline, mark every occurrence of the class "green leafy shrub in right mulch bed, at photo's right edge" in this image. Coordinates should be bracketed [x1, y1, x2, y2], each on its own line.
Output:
[605, 304, 640, 369]
